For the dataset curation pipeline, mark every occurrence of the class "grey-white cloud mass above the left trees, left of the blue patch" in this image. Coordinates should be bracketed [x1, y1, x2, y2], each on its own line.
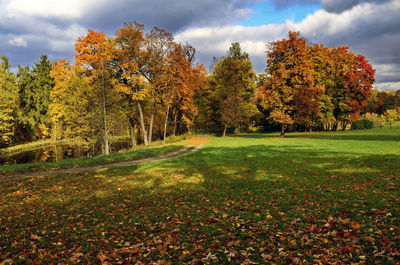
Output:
[0, 0, 258, 65]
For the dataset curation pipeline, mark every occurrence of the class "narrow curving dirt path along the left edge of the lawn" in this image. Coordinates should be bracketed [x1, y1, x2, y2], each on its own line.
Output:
[0, 136, 208, 183]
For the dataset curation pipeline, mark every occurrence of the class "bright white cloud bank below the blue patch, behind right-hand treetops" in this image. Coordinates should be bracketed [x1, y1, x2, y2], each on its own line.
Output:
[176, 0, 400, 90]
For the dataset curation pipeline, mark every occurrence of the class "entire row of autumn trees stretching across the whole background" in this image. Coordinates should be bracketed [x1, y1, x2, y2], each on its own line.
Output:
[0, 27, 400, 151]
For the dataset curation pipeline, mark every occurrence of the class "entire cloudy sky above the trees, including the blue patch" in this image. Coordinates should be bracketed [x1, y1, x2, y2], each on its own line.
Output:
[0, 0, 400, 90]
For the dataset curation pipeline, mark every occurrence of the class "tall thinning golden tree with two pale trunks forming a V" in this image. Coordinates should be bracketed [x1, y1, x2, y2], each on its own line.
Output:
[116, 23, 174, 145]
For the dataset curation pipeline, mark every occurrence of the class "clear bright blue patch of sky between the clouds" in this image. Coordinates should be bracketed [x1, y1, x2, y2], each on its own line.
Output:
[240, 1, 322, 26]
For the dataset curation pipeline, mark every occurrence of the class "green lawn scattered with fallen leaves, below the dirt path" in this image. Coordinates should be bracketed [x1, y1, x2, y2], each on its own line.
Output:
[0, 128, 400, 264]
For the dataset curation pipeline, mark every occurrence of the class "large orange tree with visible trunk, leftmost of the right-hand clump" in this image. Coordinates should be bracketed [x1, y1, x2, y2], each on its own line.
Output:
[258, 32, 324, 137]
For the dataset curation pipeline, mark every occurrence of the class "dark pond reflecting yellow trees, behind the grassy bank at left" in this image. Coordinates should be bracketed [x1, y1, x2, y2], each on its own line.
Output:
[0, 141, 132, 165]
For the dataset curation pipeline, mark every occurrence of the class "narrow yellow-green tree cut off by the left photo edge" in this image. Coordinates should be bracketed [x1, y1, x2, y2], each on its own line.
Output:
[0, 56, 19, 146]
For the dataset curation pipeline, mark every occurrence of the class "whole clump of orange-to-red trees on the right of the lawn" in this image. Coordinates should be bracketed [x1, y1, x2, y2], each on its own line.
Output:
[258, 32, 375, 136]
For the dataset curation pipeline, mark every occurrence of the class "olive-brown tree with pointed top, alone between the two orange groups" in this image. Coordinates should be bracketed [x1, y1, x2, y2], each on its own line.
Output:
[211, 43, 256, 136]
